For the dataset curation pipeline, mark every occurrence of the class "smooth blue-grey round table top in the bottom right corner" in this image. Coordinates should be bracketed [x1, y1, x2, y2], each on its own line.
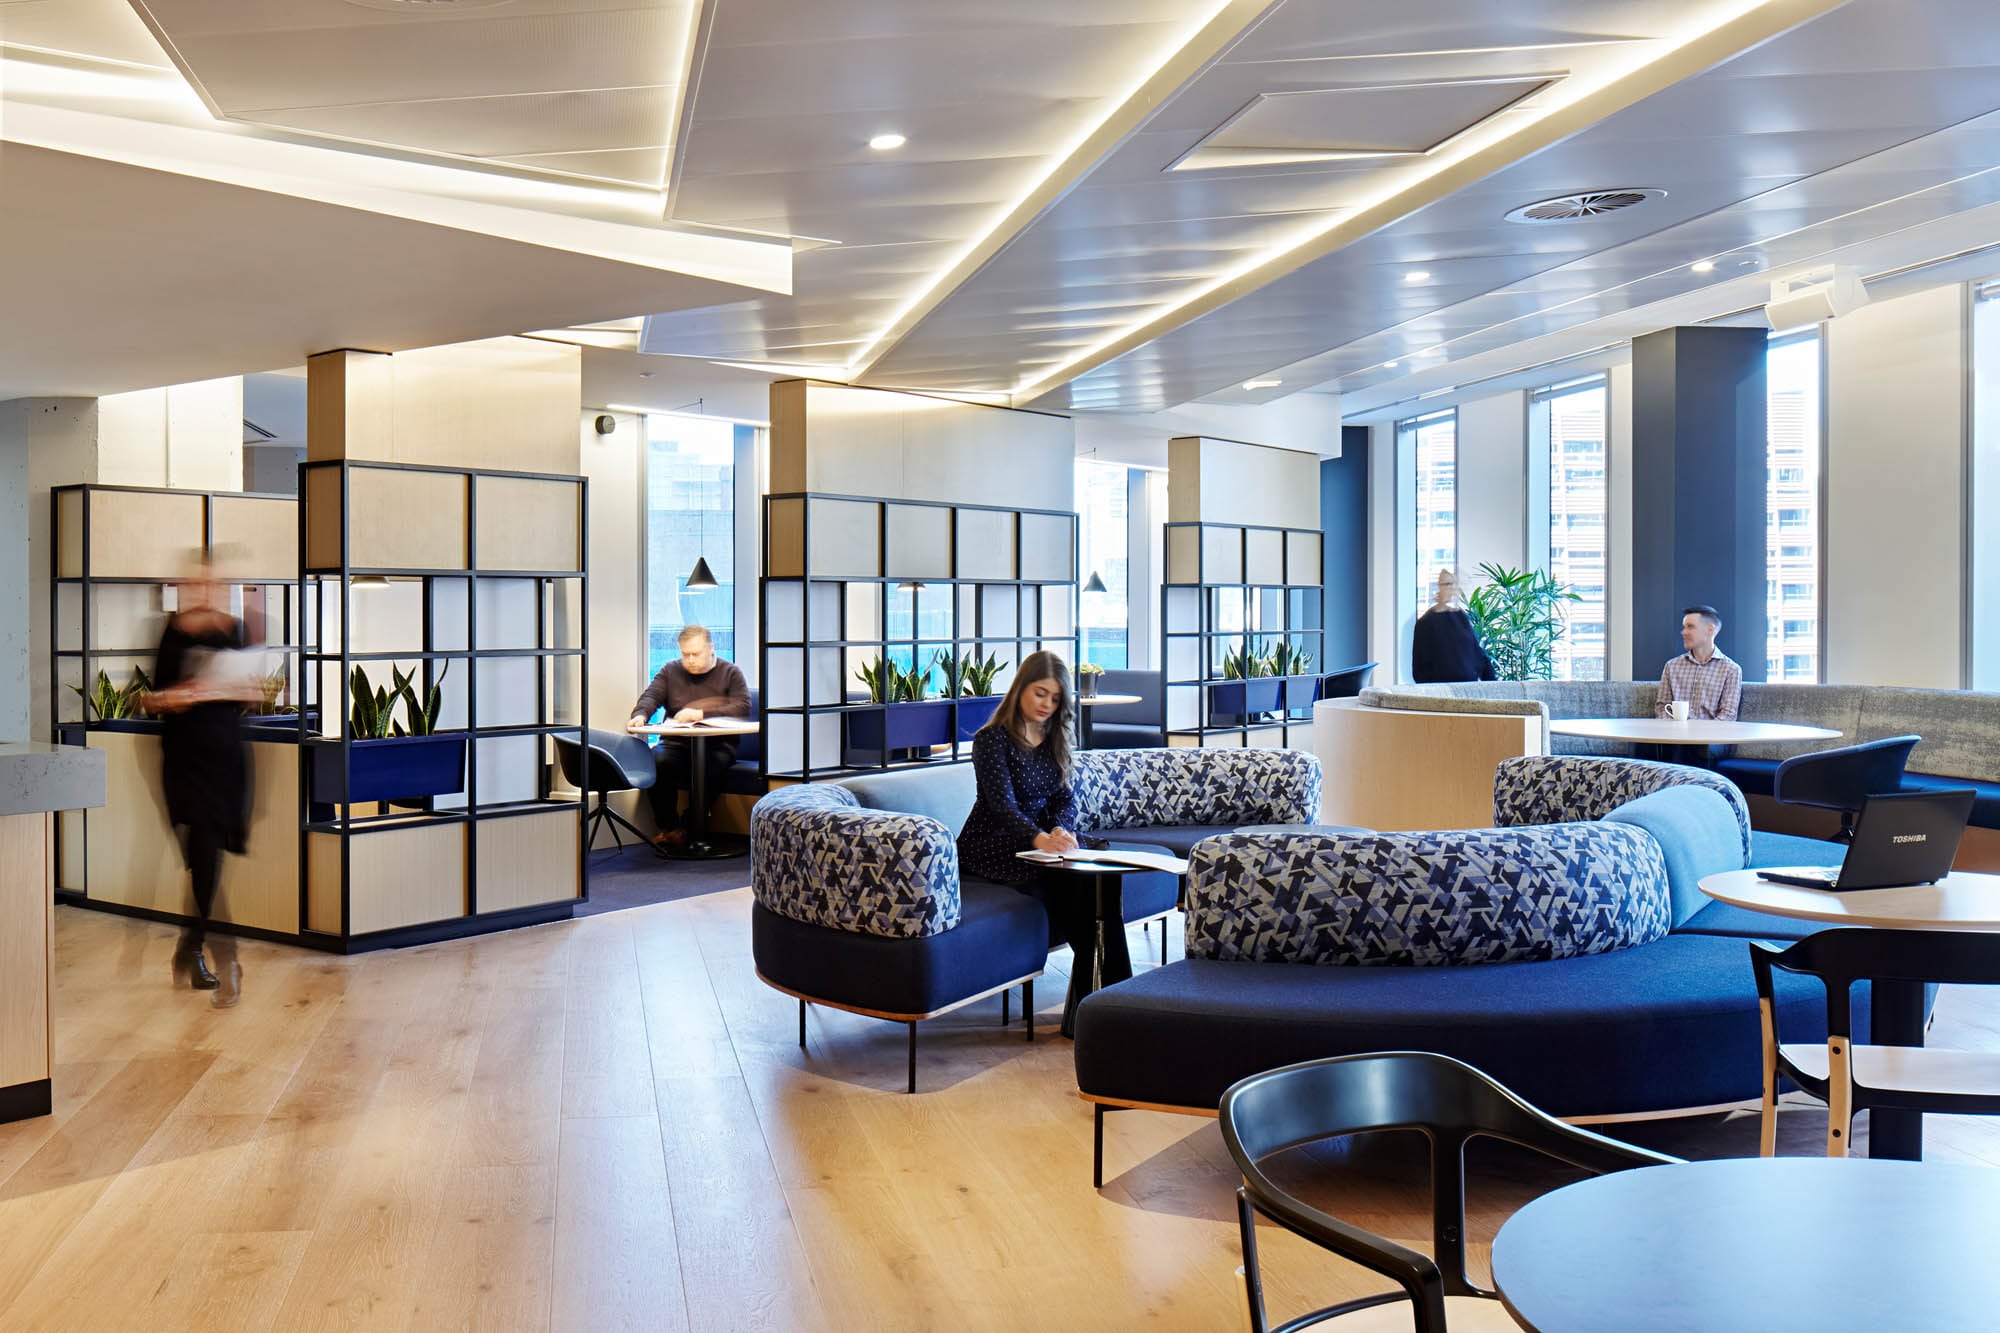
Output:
[1492, 1157, 2000, 1333]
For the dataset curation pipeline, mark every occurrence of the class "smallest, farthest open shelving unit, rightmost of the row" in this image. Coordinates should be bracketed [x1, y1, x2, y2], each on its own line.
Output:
[1160, 522, 1326, 747]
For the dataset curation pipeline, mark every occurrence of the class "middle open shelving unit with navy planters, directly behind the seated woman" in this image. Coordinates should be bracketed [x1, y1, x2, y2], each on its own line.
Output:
[758, 492, 1076, 781]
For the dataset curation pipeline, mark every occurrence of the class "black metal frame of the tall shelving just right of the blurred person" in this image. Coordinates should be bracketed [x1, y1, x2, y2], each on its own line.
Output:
[298, 458, 590, 941]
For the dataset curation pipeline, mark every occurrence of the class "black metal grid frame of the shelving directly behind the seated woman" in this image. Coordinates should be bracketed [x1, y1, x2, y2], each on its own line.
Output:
[758, 490, 1078, 783]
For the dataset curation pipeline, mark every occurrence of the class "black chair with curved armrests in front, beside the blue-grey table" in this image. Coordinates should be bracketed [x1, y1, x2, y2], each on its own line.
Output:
[1222, 1051, 1678, 1333]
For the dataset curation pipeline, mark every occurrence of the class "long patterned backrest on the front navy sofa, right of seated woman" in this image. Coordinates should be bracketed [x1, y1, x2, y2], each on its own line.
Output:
[1186, 823, 1672, 967]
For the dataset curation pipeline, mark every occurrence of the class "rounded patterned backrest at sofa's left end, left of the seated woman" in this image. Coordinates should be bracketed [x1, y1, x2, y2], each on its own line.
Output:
[750, 783, 958, 939]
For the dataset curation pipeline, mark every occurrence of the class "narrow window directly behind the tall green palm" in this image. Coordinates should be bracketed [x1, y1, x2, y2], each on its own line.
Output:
[1532, 376, 1610, 681]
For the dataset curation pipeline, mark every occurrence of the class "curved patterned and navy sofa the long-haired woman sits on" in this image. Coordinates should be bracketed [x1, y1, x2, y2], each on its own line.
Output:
[750, 749, 1320, 1093]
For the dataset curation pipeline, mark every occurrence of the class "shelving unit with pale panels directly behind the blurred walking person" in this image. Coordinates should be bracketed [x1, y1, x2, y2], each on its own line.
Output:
[48, 484, 300, 939]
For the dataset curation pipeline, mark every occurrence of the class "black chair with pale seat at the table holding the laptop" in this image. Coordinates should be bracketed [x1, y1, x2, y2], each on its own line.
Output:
[1750, 929, 2000, 1157]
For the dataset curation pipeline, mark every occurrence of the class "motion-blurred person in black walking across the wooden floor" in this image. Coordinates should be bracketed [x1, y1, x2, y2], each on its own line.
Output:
[142, 550, 262, 1009]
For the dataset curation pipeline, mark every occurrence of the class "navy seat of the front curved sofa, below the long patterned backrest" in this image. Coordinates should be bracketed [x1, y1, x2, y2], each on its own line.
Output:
[1076, 935, 1866, 1117]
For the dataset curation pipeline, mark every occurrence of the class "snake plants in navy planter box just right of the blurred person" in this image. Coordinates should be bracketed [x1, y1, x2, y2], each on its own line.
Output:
[312, 660, 466, 805]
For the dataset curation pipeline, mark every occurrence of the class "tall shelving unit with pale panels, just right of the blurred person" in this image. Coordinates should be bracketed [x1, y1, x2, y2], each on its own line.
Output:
[298, 460, 590, 949]
